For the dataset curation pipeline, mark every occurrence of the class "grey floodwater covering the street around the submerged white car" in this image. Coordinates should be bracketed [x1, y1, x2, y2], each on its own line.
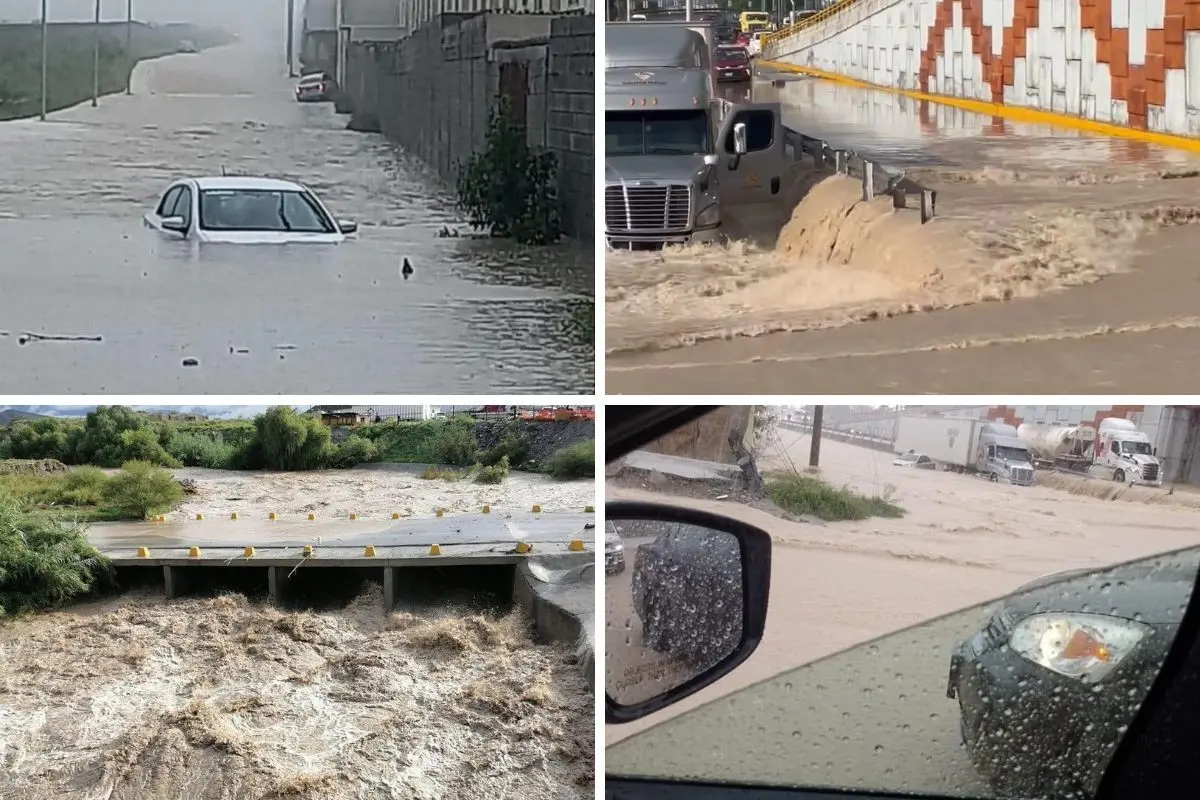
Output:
[0, 44, 595, 393]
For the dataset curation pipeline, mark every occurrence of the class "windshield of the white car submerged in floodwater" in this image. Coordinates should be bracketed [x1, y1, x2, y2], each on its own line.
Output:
[200, 188, 334, 234]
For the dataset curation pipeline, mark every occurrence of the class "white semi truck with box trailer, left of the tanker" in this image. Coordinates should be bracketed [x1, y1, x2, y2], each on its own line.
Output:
[895, 416, 1033, 486]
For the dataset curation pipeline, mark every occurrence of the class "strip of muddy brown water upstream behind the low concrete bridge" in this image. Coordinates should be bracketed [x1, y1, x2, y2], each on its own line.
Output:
[167, 464, 595, 521]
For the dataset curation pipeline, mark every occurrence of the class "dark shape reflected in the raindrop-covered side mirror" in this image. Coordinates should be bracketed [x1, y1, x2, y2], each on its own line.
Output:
[632, 523, 743, 667]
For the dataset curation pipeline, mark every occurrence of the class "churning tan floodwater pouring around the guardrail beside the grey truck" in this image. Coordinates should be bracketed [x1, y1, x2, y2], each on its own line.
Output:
[606, 148, 1200, 354]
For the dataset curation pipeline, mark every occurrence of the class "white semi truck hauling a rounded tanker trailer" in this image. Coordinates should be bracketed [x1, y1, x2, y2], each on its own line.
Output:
[1016, 416, 1163, 486]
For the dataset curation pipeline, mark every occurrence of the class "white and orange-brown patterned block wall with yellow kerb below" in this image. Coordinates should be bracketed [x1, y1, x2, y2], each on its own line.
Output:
[764, 0, 1200, 136]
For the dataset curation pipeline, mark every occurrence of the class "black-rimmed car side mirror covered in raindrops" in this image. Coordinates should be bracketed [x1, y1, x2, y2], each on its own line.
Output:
[605, 503, 770, 723]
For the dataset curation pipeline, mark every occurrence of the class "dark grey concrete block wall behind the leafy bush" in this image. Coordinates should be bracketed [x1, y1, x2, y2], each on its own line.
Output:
[344, 13, 595, 240]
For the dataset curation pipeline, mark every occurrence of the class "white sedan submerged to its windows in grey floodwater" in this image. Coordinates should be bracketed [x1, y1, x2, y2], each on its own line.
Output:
[144, 176, 359, 245]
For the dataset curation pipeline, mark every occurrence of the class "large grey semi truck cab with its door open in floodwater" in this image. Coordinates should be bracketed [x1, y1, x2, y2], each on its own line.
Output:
[604, 20, 786, 249]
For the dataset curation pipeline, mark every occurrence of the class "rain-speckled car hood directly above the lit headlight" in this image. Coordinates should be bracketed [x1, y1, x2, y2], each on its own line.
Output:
[996, 549, 1200, 628]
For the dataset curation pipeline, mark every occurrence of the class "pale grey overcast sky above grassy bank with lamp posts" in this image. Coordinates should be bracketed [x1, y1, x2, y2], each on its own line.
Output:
[0, 0, 290, 34]
